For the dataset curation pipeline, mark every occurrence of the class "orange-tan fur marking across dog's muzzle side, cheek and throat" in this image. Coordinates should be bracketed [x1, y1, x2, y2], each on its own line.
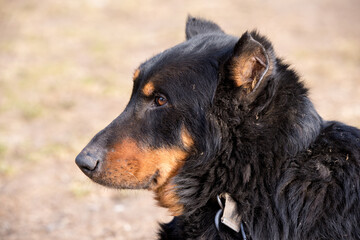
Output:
[104, 139, 191, 216]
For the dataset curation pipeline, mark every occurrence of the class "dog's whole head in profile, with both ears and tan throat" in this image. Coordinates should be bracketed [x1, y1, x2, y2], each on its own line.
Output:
[76, 18, 274, 215]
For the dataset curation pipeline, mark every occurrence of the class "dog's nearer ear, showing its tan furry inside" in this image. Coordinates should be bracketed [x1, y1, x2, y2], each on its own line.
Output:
[226, 32, 276, 100]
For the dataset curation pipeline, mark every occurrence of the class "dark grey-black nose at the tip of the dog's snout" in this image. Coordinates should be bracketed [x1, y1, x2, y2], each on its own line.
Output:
[75, 148, 101, 175]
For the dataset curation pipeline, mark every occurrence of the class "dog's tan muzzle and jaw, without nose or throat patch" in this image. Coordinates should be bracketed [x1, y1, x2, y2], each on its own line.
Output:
[83, 139, 188, 190]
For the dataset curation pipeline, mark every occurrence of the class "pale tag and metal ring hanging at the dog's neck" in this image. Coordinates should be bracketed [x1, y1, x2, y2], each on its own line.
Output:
[215, 193, 246, 240]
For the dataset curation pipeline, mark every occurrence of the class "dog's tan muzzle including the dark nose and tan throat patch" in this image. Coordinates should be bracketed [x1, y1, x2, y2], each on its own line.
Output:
[77, 135, 194, 216]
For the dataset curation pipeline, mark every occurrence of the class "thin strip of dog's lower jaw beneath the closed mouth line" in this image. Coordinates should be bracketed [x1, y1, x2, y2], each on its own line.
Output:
[90, 171, 159, 190]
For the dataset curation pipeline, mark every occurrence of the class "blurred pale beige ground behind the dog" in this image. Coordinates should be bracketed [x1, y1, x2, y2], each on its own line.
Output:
[0, 0, 360, 240]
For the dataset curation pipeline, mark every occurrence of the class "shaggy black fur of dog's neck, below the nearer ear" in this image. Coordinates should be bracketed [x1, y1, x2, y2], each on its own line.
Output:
[175, 59, 322, 236]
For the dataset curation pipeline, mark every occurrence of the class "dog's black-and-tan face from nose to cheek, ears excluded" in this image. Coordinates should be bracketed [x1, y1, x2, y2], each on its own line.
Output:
[76, 32, 222, 214]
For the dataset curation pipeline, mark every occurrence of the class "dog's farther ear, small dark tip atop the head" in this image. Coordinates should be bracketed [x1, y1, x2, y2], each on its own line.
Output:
[185, 16, 224, 40]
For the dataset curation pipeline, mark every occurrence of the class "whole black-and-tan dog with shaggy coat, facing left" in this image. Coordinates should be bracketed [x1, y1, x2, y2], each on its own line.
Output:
[76, 18, 360, 239]
